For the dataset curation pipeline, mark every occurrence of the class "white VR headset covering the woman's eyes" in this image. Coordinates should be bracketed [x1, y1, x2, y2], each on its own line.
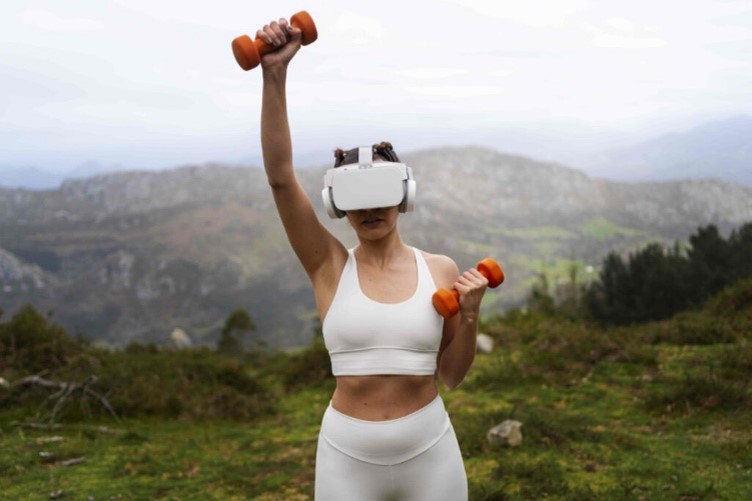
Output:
[321, 146, 415, 219]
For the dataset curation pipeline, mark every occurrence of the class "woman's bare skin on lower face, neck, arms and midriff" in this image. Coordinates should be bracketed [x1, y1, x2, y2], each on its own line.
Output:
[256, 19, 488, 421]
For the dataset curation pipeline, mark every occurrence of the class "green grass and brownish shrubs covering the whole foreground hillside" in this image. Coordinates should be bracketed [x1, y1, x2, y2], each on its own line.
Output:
[0, 222, 752, 501]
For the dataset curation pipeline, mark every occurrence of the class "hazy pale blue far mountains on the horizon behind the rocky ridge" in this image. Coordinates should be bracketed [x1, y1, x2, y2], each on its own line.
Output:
[0, 115, 752, 190]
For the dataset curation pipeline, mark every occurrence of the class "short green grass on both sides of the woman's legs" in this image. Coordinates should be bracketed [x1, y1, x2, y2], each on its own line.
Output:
[0, 347, 752, 500]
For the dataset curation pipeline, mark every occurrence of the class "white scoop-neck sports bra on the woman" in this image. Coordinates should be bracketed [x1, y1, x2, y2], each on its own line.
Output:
[322, 248, 444, 376]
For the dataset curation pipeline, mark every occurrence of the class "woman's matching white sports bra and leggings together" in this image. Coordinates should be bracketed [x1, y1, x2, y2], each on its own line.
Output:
[315, 249, 468, 501]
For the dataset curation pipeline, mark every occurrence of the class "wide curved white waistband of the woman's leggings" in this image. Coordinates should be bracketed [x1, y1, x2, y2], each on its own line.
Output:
[321, 396, 451, 465]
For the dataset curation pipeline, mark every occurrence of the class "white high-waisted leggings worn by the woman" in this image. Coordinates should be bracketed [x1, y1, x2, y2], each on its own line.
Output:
[315, 397, 468, 501]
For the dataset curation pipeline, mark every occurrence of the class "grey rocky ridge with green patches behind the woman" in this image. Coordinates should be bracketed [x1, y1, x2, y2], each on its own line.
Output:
[0, 147, 752, 346]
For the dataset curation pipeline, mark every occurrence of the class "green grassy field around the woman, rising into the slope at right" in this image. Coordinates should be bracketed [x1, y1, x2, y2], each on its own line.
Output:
[0, 286, 752, 501]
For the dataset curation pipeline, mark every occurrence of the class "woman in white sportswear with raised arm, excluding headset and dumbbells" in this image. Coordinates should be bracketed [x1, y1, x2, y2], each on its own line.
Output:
[256, 19, 488, 501]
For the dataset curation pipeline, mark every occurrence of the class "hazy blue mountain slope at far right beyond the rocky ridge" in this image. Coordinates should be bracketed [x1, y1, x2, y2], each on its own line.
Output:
[576, 116, 752, 186]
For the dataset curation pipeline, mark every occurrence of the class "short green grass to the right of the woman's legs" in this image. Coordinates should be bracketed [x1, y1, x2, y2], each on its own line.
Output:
[446, 350, 752, 499]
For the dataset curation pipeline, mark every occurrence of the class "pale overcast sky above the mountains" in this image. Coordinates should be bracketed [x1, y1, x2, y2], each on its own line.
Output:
[0, 0, 752, 184]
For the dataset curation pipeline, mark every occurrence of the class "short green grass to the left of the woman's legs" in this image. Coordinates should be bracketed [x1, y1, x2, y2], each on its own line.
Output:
[0, 408, 322, 499]
